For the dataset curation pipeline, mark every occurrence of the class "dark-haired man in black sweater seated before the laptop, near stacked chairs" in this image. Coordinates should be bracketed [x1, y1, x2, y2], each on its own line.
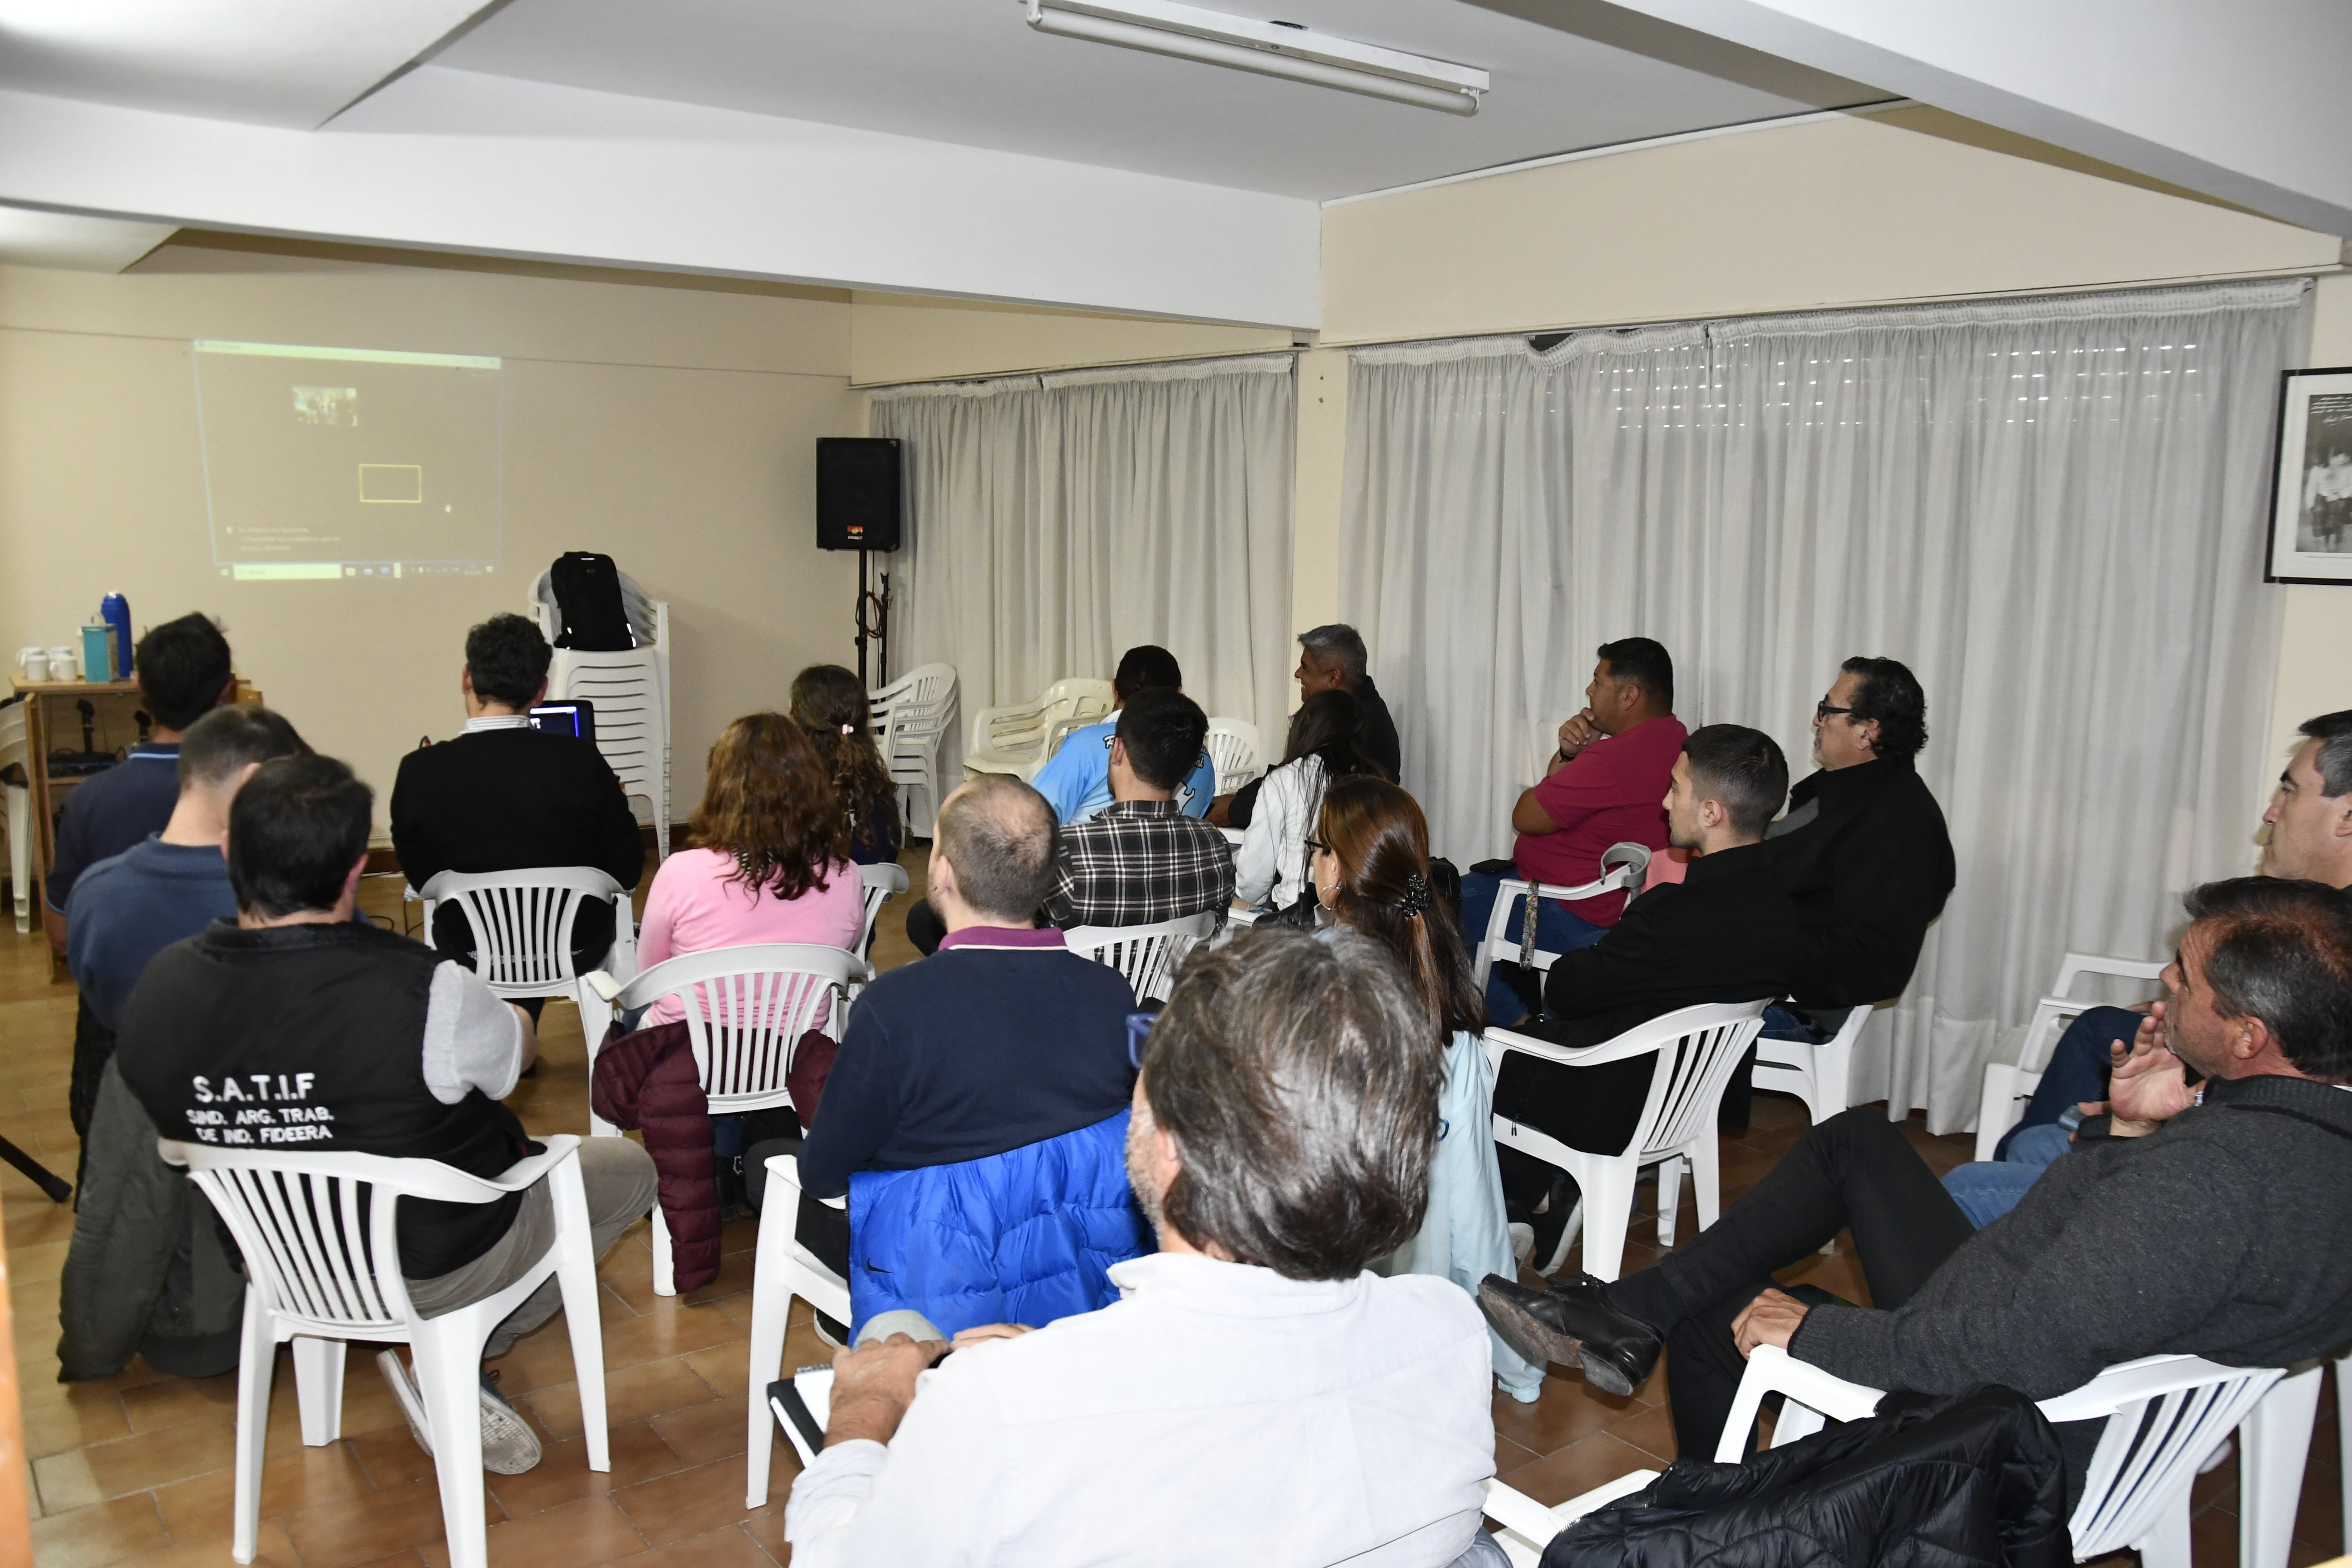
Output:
[393, 616, 644, 992]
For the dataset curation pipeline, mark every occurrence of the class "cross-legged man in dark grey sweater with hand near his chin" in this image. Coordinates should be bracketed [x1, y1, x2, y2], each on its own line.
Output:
[1479, 877, 2352, 1488]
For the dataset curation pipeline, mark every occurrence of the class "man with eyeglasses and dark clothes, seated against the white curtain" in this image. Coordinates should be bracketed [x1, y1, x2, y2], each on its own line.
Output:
[1722, 658, 1957, 1129]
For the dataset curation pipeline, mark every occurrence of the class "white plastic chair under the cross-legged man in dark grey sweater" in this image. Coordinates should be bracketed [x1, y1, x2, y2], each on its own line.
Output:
[1715, 1345, 2286, 1568]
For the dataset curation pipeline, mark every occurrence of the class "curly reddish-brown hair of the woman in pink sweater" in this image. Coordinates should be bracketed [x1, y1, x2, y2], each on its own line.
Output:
[687, 712, 849, 900]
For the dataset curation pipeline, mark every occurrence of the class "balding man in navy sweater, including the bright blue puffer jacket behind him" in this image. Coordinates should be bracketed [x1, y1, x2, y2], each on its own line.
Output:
[800, 773, 1152, 1335]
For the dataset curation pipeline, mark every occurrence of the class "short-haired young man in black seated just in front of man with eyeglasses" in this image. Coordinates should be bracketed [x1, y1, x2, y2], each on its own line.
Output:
[1494, 724, 1804, 1272]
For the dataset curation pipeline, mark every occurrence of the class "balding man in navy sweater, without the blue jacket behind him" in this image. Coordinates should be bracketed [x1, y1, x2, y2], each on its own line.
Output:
[800, 773, 1136, 1335]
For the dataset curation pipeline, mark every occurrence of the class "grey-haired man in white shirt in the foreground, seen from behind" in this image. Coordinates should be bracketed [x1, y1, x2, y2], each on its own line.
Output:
[786, 931, 1498, 1568]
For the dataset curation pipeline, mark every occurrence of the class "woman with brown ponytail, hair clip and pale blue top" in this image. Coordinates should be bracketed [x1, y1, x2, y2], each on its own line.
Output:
[1308, 778, 1543, 1403]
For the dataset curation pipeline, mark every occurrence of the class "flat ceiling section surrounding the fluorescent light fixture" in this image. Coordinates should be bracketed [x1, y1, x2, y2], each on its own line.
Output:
[433, 0, 1889, 200]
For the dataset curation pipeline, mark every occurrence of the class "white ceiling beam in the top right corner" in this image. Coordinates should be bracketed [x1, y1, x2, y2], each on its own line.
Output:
[1581, 0, 2352, 235]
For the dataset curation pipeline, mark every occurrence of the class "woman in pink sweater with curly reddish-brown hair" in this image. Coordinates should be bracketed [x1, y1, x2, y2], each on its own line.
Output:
[637, 712, 866, 1027]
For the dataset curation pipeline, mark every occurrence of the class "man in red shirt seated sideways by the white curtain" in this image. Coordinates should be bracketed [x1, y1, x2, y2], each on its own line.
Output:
[1463, 637, 1689, 1025]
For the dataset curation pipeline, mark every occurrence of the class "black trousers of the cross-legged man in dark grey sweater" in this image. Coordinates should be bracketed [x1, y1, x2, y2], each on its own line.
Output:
[1604, 1107, 1976, 1457]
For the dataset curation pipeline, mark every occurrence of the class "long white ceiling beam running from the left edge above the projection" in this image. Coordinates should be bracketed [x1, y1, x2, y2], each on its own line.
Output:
[0, 66, 1319, 327]
